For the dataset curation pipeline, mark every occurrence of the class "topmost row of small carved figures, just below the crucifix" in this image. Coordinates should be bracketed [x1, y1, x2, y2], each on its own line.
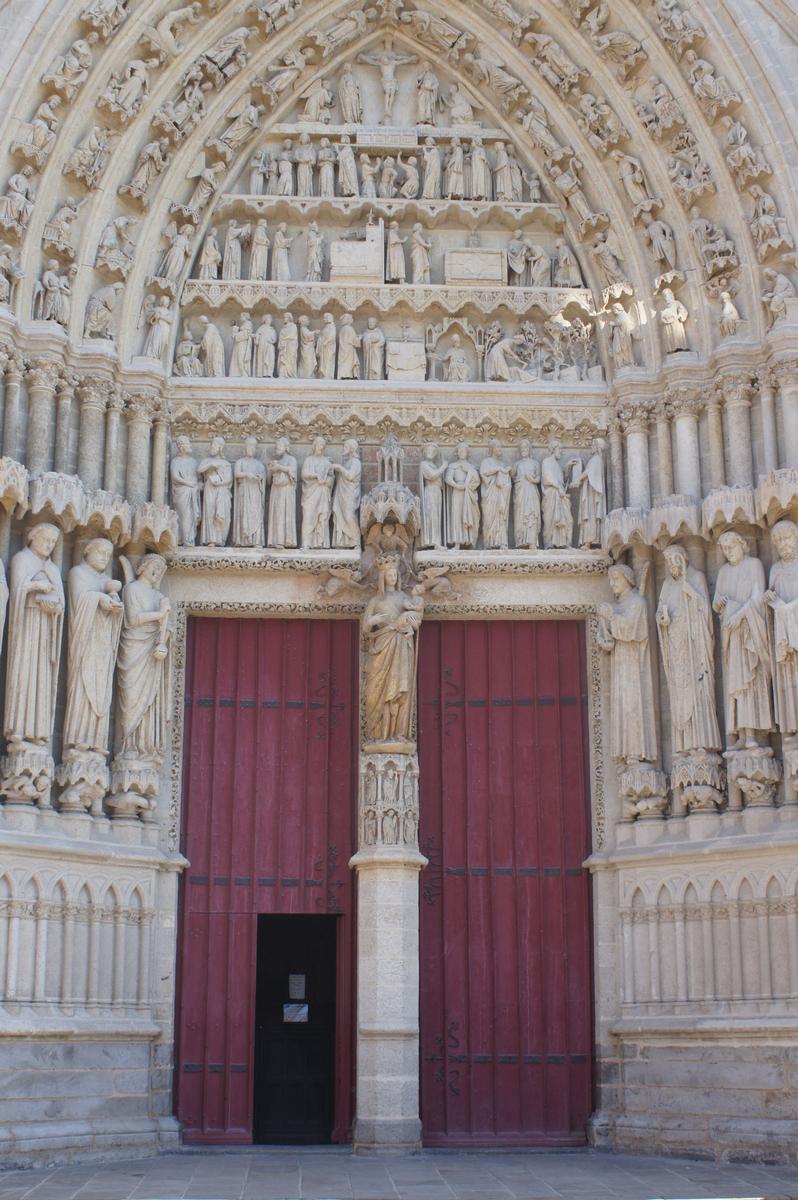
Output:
[241, 133, 540, 204]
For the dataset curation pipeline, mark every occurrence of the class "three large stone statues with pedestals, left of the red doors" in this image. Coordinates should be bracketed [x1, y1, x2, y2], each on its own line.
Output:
[0, 523, 170, 816]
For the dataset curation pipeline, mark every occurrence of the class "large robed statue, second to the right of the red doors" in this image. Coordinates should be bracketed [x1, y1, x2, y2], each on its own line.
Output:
[656, 545, 721, 754]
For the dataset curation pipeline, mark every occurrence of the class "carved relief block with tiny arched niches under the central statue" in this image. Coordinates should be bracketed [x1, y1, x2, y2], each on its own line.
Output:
[359, 752, 419, 854]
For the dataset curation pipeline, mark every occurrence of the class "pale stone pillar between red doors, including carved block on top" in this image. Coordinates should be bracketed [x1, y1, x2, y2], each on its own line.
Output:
[350, 745, 427, 1151]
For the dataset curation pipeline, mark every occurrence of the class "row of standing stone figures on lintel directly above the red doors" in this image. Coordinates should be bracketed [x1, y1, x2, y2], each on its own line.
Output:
[170, 437, 606, 550]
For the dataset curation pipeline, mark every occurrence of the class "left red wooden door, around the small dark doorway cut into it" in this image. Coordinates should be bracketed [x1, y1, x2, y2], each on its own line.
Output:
[175, 618, 358, 1144]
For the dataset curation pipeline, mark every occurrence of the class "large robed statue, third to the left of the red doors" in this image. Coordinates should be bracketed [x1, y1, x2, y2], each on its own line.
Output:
[4, 524, 64, 754]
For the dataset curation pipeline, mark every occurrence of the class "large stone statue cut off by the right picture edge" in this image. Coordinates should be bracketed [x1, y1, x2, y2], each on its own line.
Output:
[764, 521, 798, 738]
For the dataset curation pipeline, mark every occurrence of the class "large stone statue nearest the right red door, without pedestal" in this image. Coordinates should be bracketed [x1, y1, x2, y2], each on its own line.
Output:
[598, 564, 656, 764]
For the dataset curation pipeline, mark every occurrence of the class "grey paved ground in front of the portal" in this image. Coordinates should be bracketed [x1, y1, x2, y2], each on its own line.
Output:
[0, 1148, 798, 1200]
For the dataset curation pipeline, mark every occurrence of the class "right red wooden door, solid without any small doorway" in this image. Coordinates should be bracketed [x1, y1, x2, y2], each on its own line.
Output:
[419, 620, 592, 1146]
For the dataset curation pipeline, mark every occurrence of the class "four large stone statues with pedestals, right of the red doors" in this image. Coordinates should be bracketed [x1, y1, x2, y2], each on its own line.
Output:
[599, 520, 798, 815]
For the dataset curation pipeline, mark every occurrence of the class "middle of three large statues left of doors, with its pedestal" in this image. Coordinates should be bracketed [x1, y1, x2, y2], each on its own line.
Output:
[59, 538, 124, 808]
